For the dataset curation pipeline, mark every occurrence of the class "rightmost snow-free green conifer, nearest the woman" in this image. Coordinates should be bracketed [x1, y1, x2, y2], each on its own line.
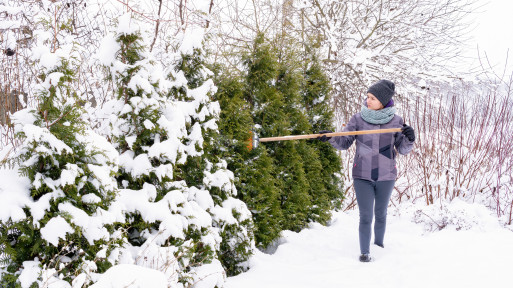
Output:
[276, 39, 343, 224]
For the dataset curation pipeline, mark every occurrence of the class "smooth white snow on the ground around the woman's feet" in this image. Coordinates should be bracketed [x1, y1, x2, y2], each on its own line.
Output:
[226, 211, 513, 288]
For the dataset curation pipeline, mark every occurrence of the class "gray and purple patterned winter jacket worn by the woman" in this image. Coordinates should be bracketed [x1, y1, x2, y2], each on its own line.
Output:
[329, 113, 414, 181]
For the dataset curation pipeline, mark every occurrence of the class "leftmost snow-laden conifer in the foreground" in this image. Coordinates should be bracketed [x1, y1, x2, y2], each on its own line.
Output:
[0, 46, 122, 287]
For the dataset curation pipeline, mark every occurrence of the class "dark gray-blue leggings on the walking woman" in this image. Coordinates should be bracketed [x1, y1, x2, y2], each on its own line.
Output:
[354, 179, 395, 254]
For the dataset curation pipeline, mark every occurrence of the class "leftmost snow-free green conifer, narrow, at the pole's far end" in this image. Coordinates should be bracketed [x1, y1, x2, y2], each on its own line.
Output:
[215, 75, 283, 249]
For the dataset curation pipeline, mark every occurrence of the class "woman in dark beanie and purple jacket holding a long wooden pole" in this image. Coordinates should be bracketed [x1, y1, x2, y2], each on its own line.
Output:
[318, 80, 415, 262]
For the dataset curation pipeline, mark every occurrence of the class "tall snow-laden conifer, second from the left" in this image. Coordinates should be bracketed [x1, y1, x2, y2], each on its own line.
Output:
[103, 21, 219, 284]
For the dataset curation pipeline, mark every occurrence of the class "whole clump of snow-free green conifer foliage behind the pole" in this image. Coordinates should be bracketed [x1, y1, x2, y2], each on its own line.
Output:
[215, 34, 343, 248]
